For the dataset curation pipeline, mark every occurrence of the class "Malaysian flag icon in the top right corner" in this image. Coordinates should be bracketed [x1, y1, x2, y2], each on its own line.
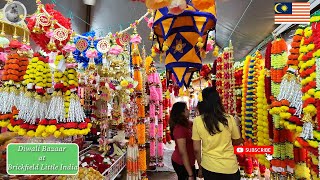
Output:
[274, 2, 310, 24]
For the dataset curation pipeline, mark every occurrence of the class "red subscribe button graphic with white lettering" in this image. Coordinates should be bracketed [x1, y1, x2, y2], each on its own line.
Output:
[234, 146, 273, 154]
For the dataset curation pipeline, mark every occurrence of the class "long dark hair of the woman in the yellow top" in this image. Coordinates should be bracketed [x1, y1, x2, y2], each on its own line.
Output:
[202, 87, 228, 135]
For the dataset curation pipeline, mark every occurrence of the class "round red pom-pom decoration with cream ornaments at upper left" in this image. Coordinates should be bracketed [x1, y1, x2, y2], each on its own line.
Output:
[26, 2, 71, 53]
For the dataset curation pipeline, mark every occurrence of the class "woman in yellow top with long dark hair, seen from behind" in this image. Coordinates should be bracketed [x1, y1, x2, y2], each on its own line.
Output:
[192, 87, 242, 180]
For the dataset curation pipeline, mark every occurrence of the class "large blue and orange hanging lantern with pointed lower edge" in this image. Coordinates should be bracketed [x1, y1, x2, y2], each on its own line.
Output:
[153, 0, 217, 87]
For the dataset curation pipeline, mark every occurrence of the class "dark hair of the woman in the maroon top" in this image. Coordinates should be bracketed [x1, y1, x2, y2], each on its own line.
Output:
[169, 102, 189, 138]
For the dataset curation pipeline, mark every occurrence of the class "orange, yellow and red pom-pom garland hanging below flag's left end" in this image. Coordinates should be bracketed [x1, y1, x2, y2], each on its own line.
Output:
[269, 39, 287, 176]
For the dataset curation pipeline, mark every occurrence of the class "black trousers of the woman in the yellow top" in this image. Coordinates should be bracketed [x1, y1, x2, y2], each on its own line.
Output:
[202, 168, 241, 180]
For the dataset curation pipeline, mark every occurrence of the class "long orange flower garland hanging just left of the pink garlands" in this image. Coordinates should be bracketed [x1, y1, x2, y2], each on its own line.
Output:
[132, 45, 147, 179]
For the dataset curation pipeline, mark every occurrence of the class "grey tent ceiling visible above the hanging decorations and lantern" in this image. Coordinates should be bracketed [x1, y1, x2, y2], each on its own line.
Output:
[0, 0, 307, 68]
